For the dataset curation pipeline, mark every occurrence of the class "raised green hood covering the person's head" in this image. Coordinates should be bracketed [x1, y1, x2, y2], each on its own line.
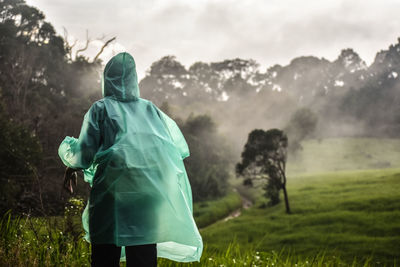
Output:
[102, 52, 140, 102]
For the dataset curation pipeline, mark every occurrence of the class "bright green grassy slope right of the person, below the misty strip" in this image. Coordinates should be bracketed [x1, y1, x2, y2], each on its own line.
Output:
[201, 169, 400, 262]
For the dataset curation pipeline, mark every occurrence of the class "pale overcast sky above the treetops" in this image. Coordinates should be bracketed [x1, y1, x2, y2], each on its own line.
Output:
[27, 0, 400, 78]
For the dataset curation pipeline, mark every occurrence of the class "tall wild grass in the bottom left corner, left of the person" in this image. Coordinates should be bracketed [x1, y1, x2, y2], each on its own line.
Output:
[0, 213, 90, 267]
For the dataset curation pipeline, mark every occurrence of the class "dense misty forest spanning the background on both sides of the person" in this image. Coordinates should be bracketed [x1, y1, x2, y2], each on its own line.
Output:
[0, 0, 400, 215]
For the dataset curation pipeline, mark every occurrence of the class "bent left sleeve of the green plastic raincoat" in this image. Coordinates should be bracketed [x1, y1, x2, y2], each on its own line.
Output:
[58, 104, 100, 170]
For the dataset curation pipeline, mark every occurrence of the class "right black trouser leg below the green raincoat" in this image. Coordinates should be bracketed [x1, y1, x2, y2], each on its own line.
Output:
[125, 244, 157, 267]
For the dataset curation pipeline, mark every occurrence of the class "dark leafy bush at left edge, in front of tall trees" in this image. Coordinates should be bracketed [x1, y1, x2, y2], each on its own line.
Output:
[0, 103, 42, 214]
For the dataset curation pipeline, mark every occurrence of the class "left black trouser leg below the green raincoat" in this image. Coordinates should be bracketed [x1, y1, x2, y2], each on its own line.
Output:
[91, 244, 121, 267]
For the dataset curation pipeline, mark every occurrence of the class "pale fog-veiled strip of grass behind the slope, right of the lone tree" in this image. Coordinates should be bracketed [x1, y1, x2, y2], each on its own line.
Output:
[287, 138, 400, 175]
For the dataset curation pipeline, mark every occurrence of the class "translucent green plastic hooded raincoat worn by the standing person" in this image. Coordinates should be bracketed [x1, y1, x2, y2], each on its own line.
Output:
[58, 53, 203, 262]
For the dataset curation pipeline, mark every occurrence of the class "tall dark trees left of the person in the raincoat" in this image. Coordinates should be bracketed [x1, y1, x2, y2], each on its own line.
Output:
[0, 0, 101, 214]
